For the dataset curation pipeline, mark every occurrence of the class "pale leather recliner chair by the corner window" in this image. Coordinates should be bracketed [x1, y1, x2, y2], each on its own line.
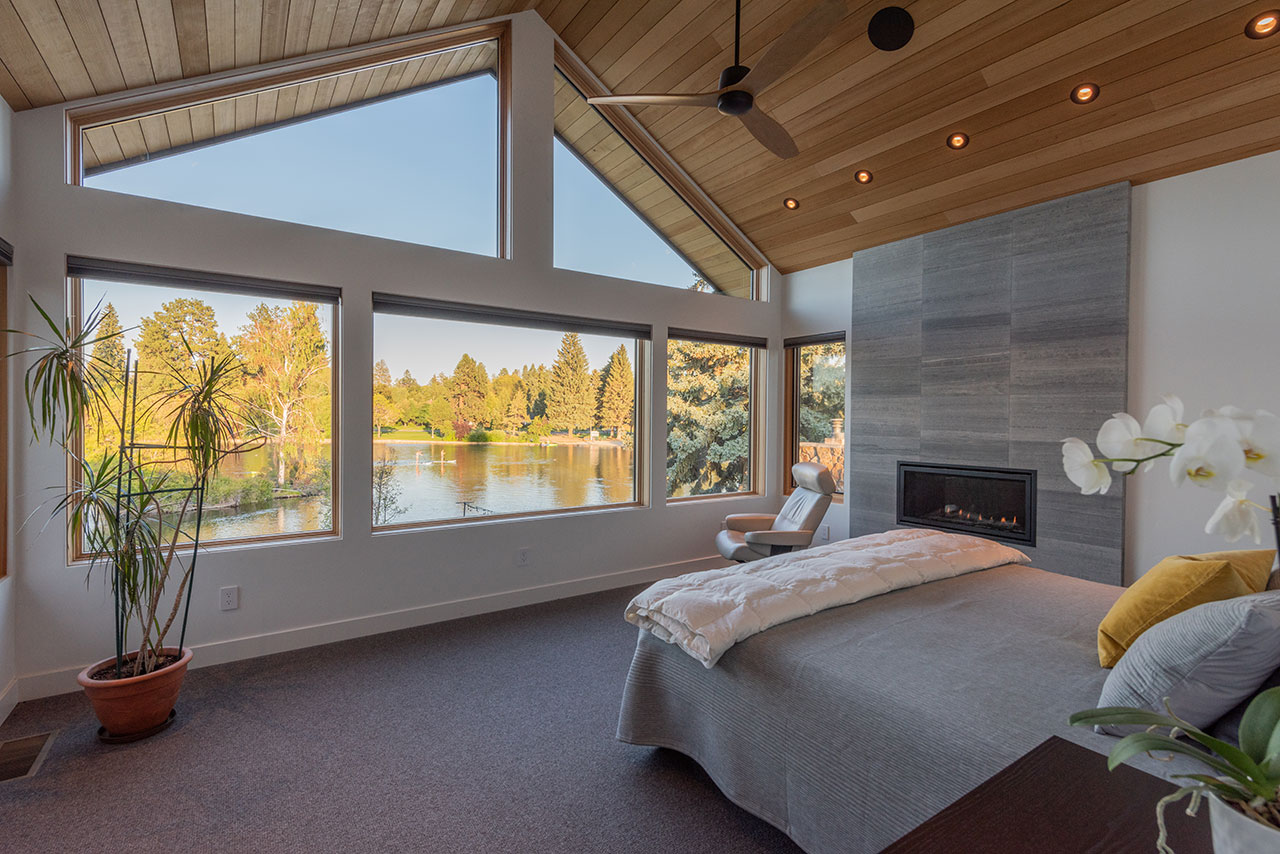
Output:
[716, 462, 836, 563]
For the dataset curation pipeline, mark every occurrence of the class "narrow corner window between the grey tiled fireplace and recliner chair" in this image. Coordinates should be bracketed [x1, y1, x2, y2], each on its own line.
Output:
[785, 333, 845, 495]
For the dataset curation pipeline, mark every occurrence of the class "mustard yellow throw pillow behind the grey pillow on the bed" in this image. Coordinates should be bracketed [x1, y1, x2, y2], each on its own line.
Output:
[1098, 551, 1276, 667]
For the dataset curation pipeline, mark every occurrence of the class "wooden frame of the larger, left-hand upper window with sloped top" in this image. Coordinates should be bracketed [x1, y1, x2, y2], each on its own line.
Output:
[65, 20, 511, 260]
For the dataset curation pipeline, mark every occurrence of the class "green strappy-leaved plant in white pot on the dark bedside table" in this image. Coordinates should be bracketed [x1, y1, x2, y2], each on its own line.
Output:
[1071, 688, 1280, 854]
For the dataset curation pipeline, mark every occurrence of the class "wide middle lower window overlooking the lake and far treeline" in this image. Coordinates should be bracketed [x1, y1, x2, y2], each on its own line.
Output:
[372, 296, 649, 528]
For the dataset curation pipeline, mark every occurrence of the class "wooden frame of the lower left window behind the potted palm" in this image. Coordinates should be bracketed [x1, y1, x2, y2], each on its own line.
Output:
[67, 256, 343, 563]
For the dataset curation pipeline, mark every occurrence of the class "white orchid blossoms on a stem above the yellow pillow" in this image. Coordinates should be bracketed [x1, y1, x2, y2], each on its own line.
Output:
[1062, 394, 1280, 547]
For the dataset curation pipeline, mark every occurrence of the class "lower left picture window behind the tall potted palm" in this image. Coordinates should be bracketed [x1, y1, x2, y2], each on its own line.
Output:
[69, 260, 338, 556]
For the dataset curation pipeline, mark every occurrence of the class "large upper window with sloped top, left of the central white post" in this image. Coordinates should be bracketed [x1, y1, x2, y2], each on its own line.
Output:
[77, 40, 500, 255]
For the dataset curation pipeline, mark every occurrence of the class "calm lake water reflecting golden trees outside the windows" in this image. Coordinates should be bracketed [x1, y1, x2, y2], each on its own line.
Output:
[201, 442, 635, 540]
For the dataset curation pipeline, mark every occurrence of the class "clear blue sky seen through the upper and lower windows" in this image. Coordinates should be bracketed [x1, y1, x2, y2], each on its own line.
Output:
[84, 71, 692, 379]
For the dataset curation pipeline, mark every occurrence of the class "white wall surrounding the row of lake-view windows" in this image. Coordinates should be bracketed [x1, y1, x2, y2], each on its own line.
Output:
[9, 13, 781, 699]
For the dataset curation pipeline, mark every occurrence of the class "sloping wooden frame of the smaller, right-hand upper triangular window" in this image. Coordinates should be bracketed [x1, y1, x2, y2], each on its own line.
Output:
[553, 38, 769, 299]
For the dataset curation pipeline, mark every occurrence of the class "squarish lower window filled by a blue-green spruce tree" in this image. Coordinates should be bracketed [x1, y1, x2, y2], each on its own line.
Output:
[667, 329, 765, 498]
